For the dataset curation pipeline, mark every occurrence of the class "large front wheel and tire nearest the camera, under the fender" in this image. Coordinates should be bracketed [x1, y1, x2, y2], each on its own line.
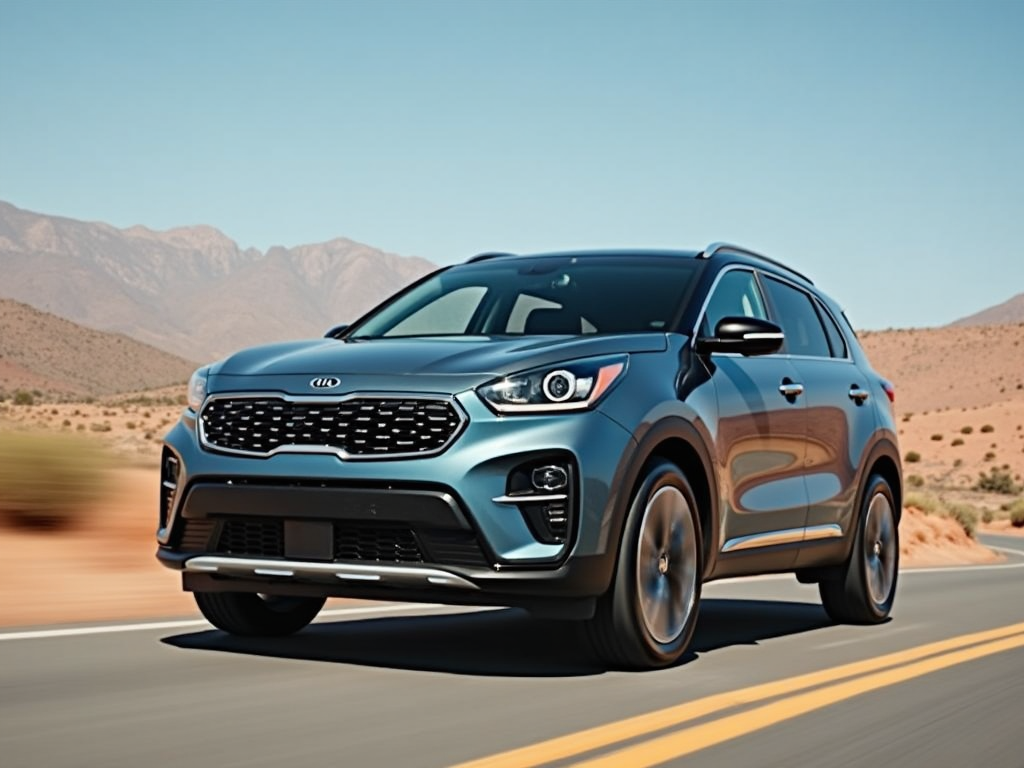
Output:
[587, 461, 703, 669]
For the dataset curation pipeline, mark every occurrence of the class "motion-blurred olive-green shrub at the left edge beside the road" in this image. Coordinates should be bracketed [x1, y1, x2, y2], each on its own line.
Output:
[0, 432, 110, 529]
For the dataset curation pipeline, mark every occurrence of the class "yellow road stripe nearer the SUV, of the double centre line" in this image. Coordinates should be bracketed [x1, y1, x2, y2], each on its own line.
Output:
[453, 623, 1024, 768]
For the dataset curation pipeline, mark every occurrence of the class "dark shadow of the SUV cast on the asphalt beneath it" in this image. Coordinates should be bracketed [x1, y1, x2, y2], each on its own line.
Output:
[162, 599, 833, 677]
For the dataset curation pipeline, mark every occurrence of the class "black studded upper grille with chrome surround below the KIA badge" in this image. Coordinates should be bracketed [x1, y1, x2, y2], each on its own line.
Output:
[201, 396, 463, 458]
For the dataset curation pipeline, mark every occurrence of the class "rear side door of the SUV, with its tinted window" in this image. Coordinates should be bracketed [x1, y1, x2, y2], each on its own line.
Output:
[763, 275, 876, 567]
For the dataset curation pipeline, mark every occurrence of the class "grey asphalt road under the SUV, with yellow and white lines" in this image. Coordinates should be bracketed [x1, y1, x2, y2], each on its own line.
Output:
[0, 538, 1024, 768]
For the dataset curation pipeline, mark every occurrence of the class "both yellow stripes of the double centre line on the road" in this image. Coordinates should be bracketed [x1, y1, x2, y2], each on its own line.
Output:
[453, 624, 1024, 768]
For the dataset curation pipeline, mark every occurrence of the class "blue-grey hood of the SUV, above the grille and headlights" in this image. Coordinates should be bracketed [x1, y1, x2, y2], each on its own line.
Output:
[210, 333, 668, 383]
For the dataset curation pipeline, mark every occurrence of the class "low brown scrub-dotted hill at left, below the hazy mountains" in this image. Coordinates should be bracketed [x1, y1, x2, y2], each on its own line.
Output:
[0, 299, 196, 398]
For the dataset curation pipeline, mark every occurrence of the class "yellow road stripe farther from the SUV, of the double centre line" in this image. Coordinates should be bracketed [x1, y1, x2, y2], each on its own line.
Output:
[572, 635, 1024, 768]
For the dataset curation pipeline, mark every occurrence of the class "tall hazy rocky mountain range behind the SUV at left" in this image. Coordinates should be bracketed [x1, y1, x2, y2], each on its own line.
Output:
[0, 202, 434, 361]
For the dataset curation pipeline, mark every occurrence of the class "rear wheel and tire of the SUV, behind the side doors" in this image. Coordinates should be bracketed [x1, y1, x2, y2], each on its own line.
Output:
[818, 475, 899, 624]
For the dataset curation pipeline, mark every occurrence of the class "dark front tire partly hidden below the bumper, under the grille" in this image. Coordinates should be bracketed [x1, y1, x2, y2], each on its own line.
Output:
[194, 592, 326, 637]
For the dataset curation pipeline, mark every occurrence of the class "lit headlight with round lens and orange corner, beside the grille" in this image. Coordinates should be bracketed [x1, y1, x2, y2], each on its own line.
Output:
[476, 355, 628, 414]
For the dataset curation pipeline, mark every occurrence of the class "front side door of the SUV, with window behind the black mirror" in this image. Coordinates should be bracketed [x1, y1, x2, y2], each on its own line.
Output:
[698, 267, 807, 575]
